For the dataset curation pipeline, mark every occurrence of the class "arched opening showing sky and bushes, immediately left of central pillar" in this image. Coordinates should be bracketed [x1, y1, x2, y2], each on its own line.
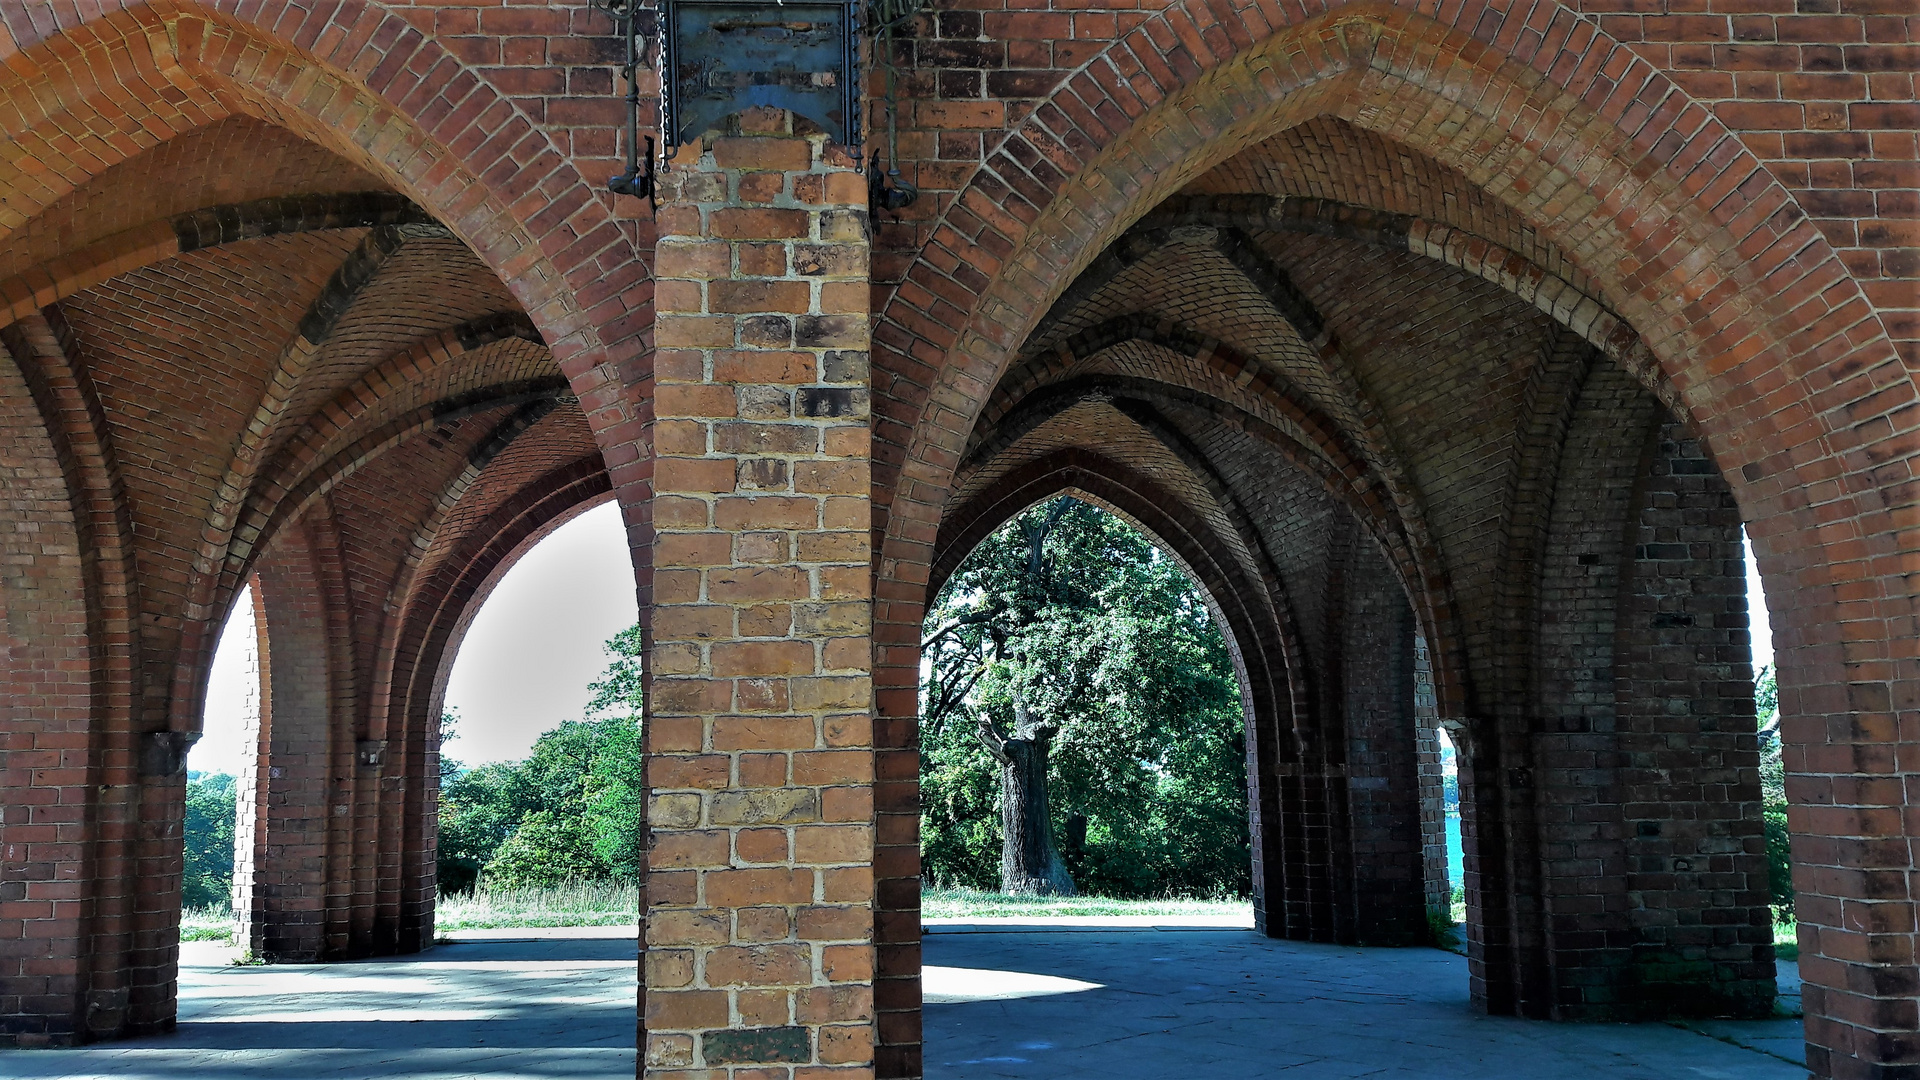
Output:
[436, 503, 645, 932]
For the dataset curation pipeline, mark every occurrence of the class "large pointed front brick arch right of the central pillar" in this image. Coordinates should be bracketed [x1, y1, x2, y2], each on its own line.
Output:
[876, 4, 1916, 1074]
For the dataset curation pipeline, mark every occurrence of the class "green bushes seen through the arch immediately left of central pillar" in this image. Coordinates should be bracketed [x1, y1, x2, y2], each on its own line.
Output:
[438, 626, 643, 894]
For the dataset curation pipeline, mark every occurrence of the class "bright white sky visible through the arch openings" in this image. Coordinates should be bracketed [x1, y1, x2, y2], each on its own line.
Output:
[188, 503, 1774, 776]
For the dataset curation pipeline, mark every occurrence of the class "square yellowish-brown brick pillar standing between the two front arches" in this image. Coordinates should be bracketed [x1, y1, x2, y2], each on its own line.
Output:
[643, 113, 874, 1080]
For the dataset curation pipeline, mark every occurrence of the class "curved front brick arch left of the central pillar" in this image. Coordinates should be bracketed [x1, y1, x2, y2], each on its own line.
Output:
[0, 0, 651, 714]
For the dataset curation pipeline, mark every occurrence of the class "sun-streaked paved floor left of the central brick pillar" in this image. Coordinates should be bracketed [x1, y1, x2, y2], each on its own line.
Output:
[0, 926, 639, 1080]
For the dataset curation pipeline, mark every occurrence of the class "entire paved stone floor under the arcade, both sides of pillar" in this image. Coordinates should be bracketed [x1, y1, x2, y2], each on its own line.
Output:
[0, 928, 1805, 1080]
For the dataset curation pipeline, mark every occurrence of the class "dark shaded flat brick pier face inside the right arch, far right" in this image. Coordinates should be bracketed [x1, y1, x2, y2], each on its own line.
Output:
[1613, 419, 1774, 1017]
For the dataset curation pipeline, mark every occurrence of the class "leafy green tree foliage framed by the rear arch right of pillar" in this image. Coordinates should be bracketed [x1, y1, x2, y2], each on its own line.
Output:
[920, 500, 1250, 897]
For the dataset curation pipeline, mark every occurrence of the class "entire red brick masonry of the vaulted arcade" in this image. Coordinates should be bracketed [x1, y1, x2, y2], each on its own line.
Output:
[0, 0, 1920, 1078]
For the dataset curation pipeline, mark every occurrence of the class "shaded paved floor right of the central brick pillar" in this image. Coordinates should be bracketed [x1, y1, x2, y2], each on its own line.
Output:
[924, 926, 1807, 1080]
